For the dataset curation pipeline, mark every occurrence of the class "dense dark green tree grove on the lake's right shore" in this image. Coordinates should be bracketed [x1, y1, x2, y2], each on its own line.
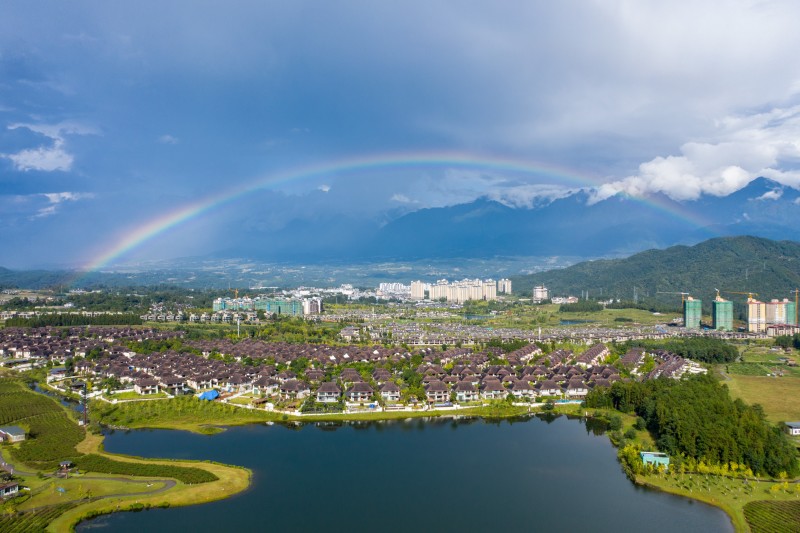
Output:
[586, 375, 798, 476]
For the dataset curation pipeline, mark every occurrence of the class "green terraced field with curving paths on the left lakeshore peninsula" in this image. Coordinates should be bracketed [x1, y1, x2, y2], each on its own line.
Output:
[0, 374, 250, 532]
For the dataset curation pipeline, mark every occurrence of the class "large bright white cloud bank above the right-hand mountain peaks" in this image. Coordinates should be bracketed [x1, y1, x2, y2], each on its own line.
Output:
[591, 105, 800, 203]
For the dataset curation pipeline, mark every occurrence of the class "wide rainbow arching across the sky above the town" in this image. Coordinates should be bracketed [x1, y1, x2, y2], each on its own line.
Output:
[73, 152, 708, 273]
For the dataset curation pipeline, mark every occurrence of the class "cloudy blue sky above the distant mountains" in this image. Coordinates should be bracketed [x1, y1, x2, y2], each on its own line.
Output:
[0, 0, 800, 268]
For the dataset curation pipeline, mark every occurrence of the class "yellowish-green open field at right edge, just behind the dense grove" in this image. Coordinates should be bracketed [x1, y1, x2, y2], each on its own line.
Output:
[725, 375, 800, 423]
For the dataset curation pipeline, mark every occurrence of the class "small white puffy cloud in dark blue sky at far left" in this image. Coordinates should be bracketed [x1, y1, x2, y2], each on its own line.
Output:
[1, 122, 97, 172]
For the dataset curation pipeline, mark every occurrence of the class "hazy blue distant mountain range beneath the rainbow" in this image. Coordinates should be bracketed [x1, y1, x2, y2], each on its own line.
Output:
[228, 178, 800, 262]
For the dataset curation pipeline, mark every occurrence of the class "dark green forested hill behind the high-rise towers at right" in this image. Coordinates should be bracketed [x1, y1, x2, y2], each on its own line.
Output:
[512, 237, 800, 308]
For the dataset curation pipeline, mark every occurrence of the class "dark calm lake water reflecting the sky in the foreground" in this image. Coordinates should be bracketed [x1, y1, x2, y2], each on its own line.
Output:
[78, 417, 733, 533]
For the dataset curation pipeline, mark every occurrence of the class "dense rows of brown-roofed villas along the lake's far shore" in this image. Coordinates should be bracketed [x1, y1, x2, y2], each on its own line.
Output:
[75, 343, 632, 403]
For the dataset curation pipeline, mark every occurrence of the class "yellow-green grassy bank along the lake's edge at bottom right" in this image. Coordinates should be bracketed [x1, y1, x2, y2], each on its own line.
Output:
[636, 474, 800, 532]
